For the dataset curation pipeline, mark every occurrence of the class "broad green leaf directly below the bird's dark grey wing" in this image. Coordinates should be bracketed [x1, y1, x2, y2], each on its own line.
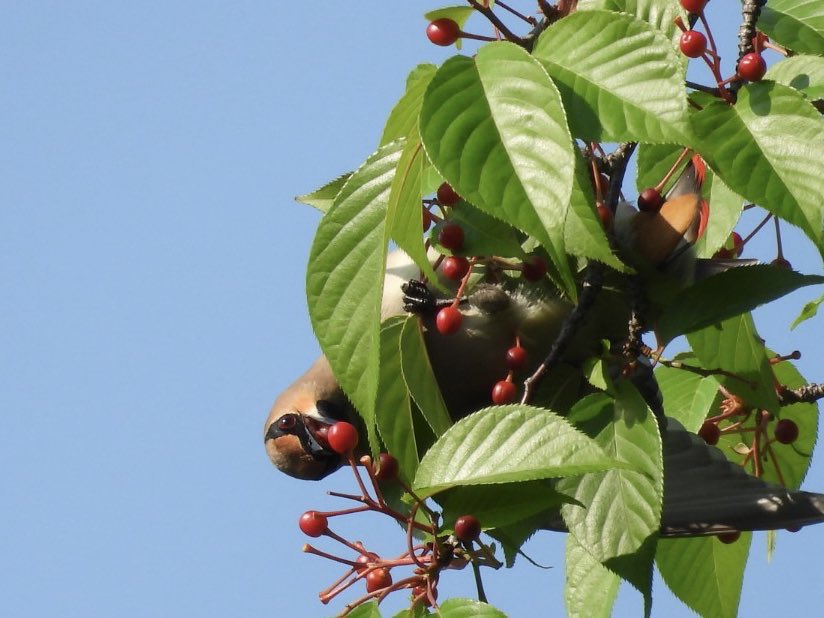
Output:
[655, 532, 752, 618]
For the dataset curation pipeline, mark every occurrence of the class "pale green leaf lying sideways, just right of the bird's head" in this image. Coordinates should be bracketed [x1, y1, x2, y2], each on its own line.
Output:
[414, 405, 622, 494]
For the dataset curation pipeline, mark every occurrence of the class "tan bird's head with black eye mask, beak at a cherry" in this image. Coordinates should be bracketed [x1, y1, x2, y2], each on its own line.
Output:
[263, 356, 357, 481]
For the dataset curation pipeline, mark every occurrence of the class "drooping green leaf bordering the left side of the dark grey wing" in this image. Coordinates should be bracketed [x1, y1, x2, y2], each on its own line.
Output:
[558, 380, 663, 563]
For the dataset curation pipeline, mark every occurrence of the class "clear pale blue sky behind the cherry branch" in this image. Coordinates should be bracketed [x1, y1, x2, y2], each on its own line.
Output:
[0, 0, 824, 618]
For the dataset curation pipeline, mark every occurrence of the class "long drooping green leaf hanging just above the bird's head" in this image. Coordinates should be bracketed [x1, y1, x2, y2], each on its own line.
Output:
[306, 142, 403, 450]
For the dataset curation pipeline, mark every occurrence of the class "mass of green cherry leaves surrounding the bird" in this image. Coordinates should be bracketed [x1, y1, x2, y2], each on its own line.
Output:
[298, 0, 824, 618]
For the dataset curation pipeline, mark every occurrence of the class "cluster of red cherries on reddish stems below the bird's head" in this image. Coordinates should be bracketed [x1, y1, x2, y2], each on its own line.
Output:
[298, 421, 490, 615]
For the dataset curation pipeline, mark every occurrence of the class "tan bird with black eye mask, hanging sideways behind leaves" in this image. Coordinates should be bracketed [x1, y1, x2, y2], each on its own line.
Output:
[264, 161, 824, 537]
